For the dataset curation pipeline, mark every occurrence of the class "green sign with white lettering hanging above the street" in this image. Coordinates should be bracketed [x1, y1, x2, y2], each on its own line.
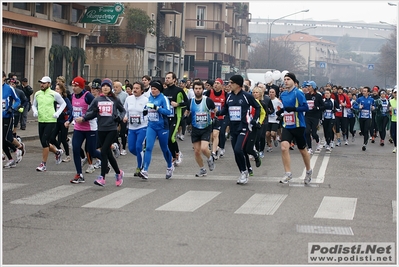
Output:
[80, 3, 124, 24]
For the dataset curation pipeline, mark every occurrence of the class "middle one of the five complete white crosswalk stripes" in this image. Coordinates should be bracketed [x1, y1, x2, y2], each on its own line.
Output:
[156, 191, 221, 212]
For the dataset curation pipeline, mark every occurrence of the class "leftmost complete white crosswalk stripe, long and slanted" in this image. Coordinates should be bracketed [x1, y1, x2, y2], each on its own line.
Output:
[10, 185, 91, 205]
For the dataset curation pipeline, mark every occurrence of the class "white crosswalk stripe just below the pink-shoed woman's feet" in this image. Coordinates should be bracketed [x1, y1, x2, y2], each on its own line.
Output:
[82, 188, 155, 209]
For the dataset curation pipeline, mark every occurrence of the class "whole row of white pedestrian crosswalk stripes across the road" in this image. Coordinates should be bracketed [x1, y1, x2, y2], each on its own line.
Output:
[2, 183, 396, 223]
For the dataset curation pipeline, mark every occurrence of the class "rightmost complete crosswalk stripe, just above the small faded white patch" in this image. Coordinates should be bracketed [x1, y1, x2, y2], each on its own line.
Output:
[314, 196, 357, 220]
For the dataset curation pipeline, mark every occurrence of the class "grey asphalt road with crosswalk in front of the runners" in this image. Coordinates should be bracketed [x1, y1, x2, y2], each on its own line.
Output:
[2, 123, 397, 265]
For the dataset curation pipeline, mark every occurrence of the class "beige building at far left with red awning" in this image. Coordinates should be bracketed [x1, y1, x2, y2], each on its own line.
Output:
[2, 2, 90, 90]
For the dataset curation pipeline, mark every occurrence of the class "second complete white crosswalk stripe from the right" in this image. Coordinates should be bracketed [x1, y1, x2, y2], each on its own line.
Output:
[234, 194, 288, 215]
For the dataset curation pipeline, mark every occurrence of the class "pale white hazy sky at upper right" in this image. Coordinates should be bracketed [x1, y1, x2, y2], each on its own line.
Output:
[249, 0, 399, 24]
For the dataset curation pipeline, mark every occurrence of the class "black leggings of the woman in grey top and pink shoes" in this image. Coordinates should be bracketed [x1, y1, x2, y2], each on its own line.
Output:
[98, 130, 120, 179]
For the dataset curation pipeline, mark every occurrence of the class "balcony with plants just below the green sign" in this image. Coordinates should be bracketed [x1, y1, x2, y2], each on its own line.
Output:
[86, 29, 146, 48]
